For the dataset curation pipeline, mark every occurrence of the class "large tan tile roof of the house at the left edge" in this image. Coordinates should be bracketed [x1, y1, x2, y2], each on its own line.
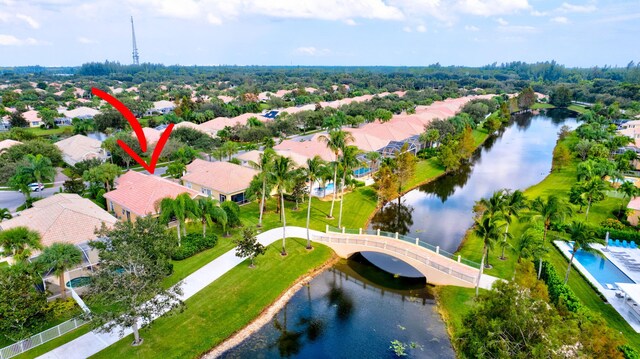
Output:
[0, 193, 116, 250]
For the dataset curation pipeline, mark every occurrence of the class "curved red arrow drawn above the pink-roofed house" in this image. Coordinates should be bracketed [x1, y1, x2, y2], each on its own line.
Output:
[91, 87, 173, 174]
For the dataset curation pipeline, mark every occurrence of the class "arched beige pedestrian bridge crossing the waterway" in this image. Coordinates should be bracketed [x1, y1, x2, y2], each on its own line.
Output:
[311, 226, 498, 289]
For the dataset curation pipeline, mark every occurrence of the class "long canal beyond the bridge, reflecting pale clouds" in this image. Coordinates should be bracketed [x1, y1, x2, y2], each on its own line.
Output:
[370, 110, 576, 253]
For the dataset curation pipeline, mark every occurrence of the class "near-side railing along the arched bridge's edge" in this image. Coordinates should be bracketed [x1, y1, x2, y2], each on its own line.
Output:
[314, 236, 477, 283]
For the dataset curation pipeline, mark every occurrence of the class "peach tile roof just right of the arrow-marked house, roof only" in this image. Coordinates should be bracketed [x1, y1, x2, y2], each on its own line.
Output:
[182, 159, 258, 194]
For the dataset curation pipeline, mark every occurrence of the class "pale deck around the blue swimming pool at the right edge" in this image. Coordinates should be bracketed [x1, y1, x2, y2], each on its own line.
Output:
[553, 241, 640, 333]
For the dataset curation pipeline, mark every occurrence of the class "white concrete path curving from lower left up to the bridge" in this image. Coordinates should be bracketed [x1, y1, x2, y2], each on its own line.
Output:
[39, 227, 321, 359]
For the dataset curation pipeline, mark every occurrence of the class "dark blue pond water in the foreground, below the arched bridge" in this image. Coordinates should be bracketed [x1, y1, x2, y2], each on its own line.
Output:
[222, 260, 454, 358]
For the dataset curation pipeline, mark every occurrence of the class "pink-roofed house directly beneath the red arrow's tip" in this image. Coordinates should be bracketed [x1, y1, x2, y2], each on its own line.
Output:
[104, 171, 198, 221]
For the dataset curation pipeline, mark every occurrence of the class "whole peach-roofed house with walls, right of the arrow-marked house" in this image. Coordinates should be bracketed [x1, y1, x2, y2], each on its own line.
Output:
[182, 159, 258, 203]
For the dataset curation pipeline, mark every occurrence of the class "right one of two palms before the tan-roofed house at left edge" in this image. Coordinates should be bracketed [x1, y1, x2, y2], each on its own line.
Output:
[38, 243, 82, 299]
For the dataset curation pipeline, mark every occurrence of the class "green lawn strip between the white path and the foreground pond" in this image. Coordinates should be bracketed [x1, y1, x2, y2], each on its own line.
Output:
[93, 239, 332, 358]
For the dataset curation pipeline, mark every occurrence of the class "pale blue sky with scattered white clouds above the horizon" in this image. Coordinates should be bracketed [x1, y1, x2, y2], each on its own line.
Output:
[0, 0, 640, 67]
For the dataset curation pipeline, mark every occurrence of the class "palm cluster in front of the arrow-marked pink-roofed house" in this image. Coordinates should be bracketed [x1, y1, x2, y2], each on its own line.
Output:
[158, 193, 227, 246]
